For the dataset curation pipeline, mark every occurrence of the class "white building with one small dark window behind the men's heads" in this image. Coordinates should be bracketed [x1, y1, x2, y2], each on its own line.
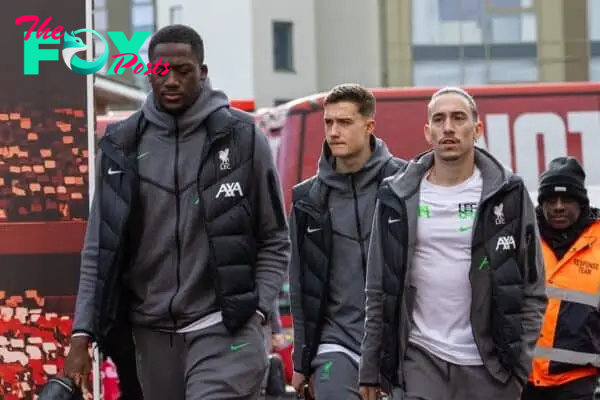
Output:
[156, 0, 382, 107]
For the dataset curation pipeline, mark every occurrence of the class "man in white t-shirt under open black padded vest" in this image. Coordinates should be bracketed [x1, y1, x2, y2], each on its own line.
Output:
[360, 87, 547, 400]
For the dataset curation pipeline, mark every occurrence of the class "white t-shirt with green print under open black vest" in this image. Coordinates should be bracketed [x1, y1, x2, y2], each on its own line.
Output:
[409, 169, 483, 365]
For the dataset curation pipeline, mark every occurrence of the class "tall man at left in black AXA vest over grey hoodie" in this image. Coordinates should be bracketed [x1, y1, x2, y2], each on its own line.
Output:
[65, 25, 290, 400]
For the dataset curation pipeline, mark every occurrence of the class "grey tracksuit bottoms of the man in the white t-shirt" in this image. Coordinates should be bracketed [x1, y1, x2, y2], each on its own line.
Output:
[392, 344, 521, 400]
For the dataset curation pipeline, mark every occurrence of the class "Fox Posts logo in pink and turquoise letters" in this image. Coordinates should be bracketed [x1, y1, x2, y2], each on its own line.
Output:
[15, 15, 170, 75]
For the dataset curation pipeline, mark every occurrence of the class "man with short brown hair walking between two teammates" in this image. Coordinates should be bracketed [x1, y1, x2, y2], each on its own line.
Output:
[289, 84, 405, 400]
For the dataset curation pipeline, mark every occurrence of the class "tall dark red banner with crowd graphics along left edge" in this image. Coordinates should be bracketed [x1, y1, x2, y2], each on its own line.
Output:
[0, 0, 88, 400]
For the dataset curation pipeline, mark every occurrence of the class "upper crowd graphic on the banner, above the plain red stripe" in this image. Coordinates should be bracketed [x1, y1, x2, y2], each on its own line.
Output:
[0, 106, 88, 222]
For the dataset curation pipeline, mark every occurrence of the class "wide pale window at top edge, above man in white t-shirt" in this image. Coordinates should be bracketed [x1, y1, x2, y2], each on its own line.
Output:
[412, 0, 536, 45]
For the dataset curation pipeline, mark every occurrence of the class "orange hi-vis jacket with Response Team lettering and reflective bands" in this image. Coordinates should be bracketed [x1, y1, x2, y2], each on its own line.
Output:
[529, 220, 600, 386]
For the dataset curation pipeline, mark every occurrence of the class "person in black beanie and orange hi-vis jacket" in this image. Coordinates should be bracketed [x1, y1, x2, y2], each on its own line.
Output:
[521, 157, 600, 400]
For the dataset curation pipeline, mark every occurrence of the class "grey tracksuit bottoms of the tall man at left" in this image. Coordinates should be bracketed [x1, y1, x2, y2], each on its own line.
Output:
[133, 318, 267, 400]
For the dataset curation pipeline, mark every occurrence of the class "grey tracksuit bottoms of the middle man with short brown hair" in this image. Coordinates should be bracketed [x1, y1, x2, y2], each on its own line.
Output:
[312, 353, 360, 400]
